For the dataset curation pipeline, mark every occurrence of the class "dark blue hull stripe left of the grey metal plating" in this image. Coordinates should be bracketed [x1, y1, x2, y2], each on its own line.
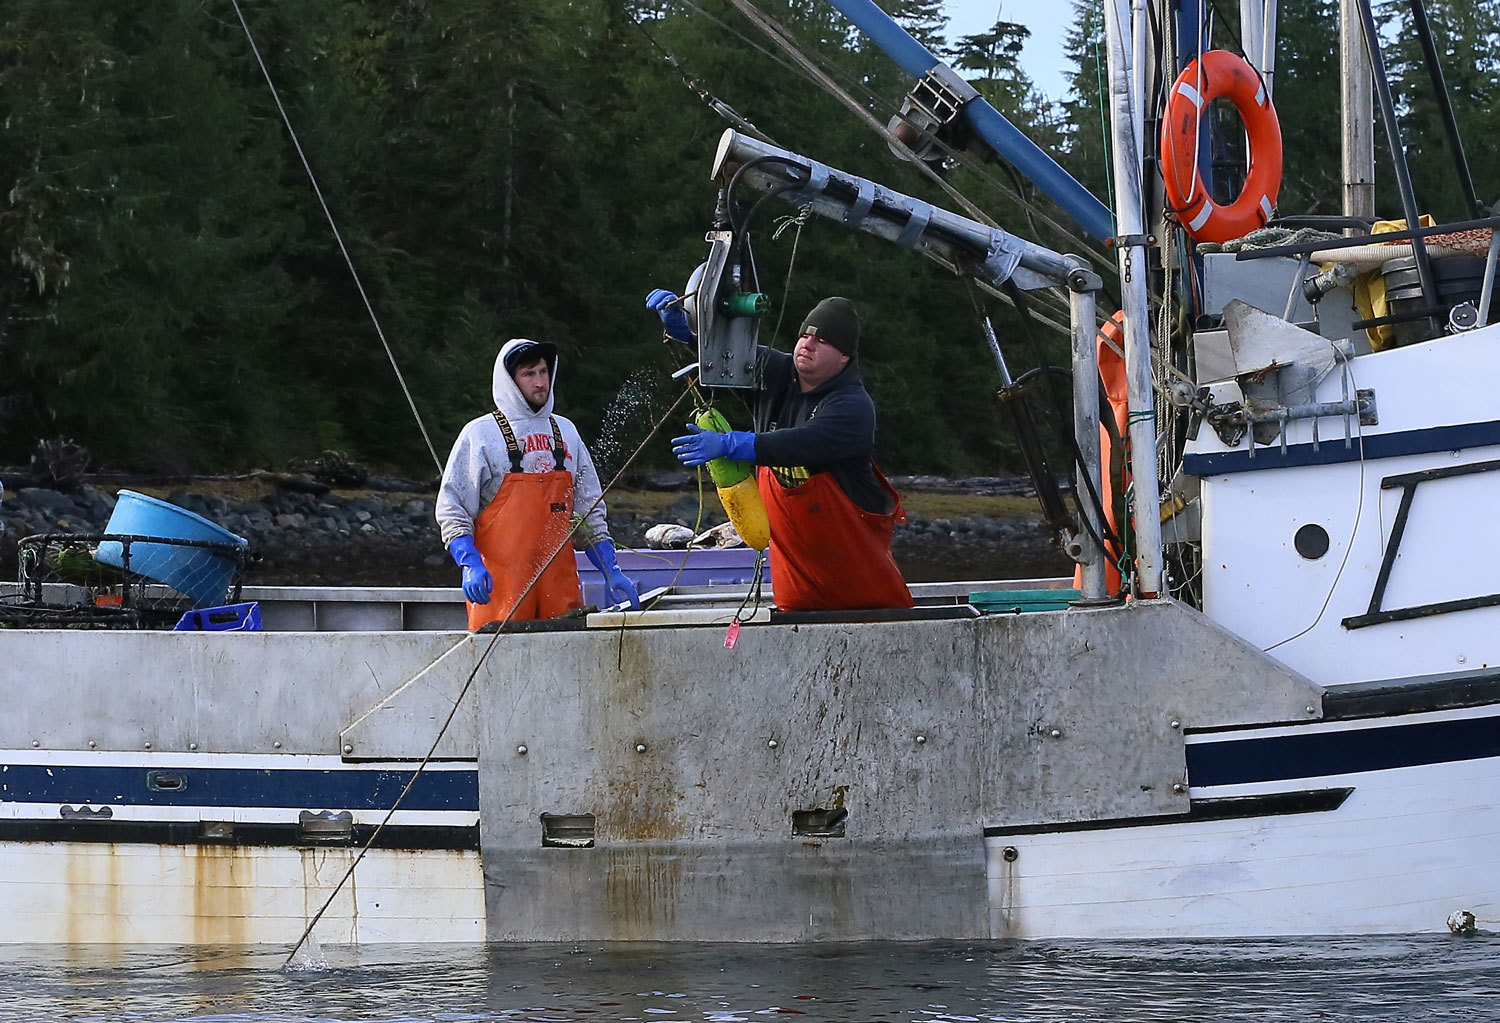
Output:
[0, 764, 479, 810]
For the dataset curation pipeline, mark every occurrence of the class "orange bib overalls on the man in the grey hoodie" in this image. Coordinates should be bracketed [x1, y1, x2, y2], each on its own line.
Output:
[468, 411, 584, 632]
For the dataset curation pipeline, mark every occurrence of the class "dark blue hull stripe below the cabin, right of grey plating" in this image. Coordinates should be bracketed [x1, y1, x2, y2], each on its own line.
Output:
[1188, 717, 1500, 788]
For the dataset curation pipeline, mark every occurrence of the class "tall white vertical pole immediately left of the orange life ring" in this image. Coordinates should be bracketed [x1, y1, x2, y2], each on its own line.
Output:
[1104, 0, 1161, 597]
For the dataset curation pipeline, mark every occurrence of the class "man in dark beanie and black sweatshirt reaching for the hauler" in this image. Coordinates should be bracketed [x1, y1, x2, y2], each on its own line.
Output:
[647, 290, 912, 611]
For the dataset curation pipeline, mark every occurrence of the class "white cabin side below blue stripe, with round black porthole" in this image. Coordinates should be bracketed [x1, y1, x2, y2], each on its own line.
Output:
[1203, 447, 1500, 686]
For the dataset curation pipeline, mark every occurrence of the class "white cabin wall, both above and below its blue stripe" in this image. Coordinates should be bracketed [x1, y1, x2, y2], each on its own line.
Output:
[1190, 327, 1500, 686]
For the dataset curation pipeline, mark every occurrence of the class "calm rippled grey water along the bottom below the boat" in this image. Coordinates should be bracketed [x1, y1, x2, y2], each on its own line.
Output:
[0, 936, 1500, 1023]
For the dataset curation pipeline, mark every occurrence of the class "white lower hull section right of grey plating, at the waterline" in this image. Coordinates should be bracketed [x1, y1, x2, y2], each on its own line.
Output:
[987, 759, 1500, 938]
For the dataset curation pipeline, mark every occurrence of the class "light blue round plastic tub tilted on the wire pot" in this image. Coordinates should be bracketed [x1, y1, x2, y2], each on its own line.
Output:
[95, 491, 251, 608]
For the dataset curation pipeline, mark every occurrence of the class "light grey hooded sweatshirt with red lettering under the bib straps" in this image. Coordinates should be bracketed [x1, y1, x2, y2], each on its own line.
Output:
[435, 338, 609, 548]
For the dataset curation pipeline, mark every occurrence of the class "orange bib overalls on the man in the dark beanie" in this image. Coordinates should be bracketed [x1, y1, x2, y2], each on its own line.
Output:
[756, 465, 912, 611]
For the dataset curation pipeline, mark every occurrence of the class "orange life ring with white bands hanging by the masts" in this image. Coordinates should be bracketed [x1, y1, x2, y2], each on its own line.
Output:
[1161, 50, 1281, 242]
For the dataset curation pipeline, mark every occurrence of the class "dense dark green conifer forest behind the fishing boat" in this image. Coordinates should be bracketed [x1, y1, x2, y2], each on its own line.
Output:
[0, 0, 1500, 476]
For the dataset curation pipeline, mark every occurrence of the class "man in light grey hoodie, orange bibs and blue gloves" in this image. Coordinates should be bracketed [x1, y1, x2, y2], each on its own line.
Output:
[437, 338, 641, 632]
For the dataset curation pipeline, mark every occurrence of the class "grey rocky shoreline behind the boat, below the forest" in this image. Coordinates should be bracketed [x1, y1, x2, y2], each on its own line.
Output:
[0, 474, 1070, 587]
